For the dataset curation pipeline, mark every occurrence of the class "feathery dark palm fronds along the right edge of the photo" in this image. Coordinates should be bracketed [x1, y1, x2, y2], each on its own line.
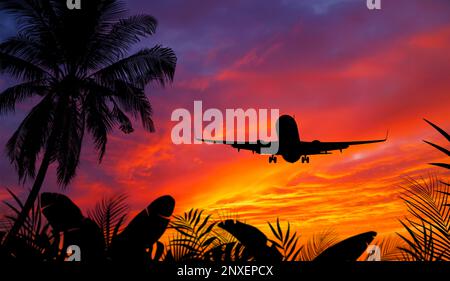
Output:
[398, 119, 450, 261]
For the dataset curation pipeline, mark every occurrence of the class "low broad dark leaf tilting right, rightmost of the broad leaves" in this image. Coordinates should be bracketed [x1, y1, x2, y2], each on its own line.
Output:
[313, 231, 377, 262]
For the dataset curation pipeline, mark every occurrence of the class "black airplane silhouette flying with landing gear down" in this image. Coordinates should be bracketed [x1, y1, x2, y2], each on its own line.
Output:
[199, 115, 387, 163]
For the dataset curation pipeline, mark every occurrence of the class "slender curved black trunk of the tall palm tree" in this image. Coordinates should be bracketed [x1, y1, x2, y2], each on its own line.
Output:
[4, 149, 50, 248]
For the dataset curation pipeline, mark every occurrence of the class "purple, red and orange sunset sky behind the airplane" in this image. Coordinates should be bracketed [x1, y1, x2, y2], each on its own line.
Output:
[0, 0, 450, 241]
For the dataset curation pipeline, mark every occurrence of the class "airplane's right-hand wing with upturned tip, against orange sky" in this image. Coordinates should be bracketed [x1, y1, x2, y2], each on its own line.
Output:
[300, 134, 387, 155]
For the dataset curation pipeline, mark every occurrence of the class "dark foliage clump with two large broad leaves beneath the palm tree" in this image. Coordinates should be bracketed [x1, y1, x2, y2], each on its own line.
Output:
[1, 190, 175, 264]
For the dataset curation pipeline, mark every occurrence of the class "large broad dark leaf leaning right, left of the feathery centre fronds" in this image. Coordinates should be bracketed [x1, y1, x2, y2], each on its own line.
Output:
[111, 195, 175, 262]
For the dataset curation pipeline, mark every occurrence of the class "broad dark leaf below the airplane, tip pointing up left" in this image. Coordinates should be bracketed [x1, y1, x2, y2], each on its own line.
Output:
[218, 220, 282, 262]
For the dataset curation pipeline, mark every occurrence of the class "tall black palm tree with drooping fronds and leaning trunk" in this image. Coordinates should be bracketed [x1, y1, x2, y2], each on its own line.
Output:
[0, 0, 176, 241]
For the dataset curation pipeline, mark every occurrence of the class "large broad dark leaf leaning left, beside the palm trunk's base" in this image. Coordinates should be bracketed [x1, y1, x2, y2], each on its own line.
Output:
[41, 192, 105, 261]
